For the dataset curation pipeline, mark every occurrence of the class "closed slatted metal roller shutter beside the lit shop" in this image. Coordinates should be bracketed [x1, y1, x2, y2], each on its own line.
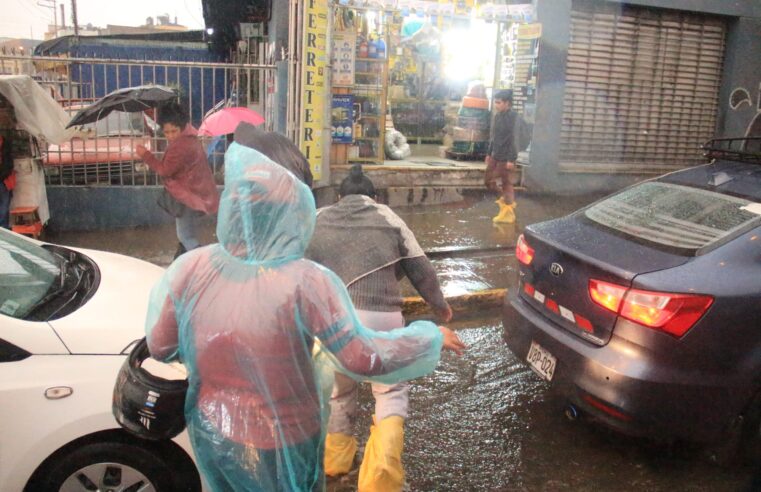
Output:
[560, 0, 726, 173]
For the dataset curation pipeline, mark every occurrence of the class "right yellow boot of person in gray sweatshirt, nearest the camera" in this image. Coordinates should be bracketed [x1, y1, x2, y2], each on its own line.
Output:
[359, 415, 404, 492]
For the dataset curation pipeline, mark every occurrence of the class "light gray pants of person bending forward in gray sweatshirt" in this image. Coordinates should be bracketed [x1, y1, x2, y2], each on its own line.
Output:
[328, 310, 409, 435]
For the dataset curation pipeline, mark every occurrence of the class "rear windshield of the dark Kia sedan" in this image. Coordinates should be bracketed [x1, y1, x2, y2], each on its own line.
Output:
[584, 182, 761, 254]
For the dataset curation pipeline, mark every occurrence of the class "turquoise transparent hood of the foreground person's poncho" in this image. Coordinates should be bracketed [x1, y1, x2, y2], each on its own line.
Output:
[217, 143, 315, 263]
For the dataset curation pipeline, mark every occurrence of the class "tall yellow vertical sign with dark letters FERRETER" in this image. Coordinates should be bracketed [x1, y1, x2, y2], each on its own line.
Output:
[301, 0, 329, 180]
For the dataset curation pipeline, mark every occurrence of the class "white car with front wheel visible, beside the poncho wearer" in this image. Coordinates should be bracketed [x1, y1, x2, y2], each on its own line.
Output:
[0, 229, 201, 492]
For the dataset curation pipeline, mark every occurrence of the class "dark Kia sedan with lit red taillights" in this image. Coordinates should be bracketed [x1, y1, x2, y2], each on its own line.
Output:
[503, 141, 761, 460]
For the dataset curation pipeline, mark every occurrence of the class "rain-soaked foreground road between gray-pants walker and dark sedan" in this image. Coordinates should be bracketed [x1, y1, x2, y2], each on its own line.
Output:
[336, 319, 751, 492]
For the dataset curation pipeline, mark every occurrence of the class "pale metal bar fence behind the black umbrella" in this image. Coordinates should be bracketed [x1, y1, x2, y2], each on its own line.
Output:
[0, 54, 277, 186]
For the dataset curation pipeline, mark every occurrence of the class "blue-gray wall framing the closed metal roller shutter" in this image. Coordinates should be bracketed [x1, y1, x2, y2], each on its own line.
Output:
[526, 0, 761, 194]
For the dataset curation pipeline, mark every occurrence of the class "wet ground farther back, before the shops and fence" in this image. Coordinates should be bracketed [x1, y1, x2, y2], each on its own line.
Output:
[48, 191, 597, 296]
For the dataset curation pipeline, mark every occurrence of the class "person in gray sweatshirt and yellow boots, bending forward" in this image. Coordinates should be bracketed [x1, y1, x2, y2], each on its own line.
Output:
[306, 165, 458, 492]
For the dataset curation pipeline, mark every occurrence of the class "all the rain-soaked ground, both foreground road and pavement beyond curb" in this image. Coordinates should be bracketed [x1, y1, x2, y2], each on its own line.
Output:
[48, 195, 755, 492]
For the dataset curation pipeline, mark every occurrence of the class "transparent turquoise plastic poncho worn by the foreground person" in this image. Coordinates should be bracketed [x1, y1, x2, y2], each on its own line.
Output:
[146, 144, 442, 491]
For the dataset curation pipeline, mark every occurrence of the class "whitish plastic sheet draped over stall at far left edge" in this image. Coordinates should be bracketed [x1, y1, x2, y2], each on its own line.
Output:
[0, 75, 77, 144]
